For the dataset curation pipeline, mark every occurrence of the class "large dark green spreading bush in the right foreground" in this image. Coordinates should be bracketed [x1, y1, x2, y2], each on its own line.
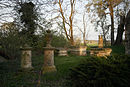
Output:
[67, 55, 130, 87]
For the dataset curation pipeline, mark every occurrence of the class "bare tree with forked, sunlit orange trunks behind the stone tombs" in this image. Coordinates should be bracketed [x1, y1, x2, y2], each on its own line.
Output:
[48, 0, 77, 45]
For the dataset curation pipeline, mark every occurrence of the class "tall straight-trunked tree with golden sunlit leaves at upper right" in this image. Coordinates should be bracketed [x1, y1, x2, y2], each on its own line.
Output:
[86, 0, 123, 45]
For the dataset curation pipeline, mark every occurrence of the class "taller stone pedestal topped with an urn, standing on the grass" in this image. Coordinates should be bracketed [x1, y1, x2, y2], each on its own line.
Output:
[43, 30, 56, 73]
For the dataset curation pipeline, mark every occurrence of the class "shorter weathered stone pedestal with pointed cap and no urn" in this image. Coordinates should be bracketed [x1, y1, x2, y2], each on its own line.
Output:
[21, 44, 33, 70]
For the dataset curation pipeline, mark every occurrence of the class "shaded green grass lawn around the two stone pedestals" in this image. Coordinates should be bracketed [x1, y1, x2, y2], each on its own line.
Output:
[0, 47, 124, 87]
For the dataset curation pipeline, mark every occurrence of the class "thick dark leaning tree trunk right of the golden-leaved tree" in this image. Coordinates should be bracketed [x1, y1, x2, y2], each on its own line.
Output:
[114, 16, 125, 45]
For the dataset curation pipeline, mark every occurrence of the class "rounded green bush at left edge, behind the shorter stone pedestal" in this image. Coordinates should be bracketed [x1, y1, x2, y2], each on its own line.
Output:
[0, 23, 22, 59]
